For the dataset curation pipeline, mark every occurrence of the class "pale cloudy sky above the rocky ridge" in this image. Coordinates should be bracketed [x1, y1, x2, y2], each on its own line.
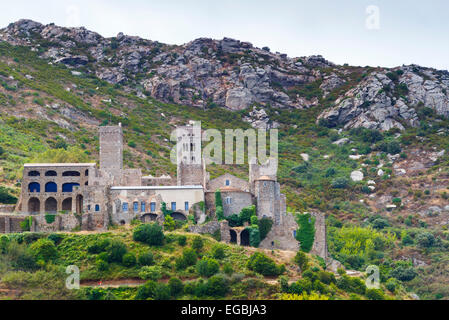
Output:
[0, 0, 449, 70]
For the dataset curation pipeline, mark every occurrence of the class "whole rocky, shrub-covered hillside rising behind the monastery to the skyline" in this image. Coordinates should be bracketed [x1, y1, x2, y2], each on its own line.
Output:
[0, 20, 449, 299]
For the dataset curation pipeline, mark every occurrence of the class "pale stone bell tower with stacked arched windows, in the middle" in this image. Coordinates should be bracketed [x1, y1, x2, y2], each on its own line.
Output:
[176, 122, 205, 186]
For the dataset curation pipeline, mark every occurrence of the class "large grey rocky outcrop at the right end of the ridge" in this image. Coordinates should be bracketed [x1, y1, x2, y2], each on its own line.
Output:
[319, 66, 449, 131]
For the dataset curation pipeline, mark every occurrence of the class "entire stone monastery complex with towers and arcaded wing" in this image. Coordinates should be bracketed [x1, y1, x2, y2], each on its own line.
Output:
[0, 123, 327, 257]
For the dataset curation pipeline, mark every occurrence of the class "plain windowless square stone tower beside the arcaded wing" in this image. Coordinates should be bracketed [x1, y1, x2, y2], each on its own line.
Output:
[100, 124, 123, 171]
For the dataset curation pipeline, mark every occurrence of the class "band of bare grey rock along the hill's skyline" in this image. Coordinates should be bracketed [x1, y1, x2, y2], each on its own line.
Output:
[0, 20, 449, 131]
